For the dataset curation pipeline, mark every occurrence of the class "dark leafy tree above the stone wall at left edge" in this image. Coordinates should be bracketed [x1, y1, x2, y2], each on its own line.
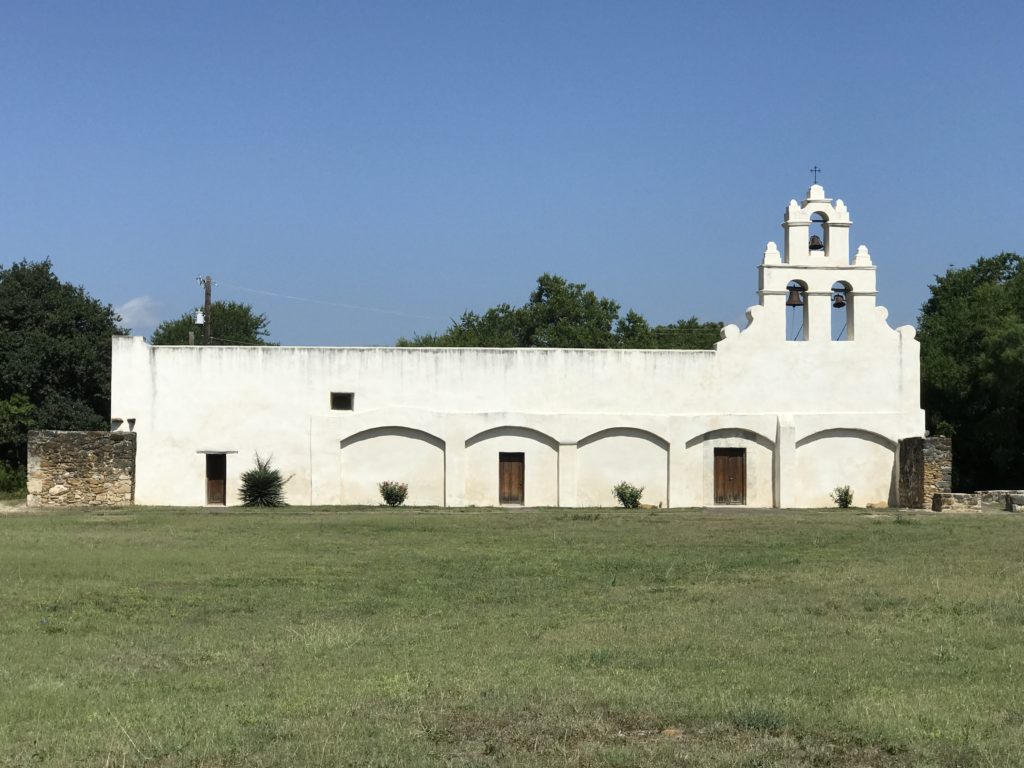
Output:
[0, 259, 125, 467]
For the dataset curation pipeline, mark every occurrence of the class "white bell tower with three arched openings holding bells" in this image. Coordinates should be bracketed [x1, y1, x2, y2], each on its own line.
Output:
[758, 183, 876, 343]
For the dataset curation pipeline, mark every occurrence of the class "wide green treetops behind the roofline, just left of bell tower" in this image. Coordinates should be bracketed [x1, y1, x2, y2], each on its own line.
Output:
[398, 273, 722, 349]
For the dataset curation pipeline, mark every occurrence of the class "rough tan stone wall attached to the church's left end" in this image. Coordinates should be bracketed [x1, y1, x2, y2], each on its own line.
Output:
[28, 430, 135, 507]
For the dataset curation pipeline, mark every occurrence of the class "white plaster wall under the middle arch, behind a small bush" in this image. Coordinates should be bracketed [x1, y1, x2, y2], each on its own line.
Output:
[577, 429, 669, 507]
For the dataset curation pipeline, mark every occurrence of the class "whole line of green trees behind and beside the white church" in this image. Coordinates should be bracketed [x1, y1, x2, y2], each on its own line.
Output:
[0, 253, 1024, 495]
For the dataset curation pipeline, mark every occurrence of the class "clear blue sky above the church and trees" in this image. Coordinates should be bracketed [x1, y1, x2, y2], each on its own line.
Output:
[0, 0, 1024, 345]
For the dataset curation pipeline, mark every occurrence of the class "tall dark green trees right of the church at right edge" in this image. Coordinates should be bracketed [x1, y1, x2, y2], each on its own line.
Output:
[918, 253, 1024, 490]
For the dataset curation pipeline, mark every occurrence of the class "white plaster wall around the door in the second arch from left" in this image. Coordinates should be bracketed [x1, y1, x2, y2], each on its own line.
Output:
[465, 427, 558, 507]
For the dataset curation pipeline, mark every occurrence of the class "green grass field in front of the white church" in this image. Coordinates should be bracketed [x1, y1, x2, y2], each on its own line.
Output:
[0, 508, 1024, 766]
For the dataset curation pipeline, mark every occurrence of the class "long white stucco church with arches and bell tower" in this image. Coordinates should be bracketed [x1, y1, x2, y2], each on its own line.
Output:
[112, 184, 925, 507]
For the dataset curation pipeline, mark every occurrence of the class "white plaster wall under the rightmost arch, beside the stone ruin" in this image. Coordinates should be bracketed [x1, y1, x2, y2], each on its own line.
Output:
[794, 428, 895, 507]
